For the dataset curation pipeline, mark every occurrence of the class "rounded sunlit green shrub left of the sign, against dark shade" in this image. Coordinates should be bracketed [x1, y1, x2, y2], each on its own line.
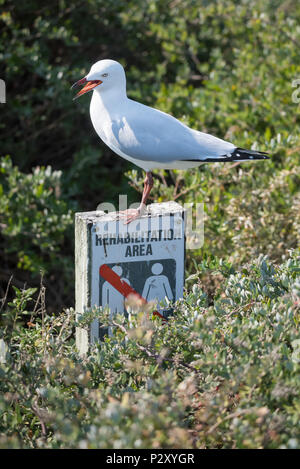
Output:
[0, 157, 73, 272]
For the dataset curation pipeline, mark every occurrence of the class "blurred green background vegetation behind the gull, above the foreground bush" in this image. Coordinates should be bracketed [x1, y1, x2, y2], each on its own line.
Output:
[0, 0, 300, 310]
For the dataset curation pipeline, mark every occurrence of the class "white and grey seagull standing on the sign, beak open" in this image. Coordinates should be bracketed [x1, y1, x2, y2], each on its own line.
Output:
[72, 59, 269, 223]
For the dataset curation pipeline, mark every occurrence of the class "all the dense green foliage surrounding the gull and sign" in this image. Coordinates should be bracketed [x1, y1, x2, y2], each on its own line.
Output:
[0, 0, 300, 448]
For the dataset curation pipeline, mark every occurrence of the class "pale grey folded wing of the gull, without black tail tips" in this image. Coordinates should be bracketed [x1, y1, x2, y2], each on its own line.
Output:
[112, 102, 236, 163]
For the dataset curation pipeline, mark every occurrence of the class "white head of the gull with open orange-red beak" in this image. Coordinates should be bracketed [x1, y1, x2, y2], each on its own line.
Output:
[72, 59, 126, 99]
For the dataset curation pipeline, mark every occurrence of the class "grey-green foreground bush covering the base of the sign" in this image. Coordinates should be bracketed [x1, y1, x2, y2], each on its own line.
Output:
[0, 252, 300, 449]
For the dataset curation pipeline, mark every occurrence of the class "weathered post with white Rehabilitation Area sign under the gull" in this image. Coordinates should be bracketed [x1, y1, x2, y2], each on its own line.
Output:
[75, 202, 185, 354]
